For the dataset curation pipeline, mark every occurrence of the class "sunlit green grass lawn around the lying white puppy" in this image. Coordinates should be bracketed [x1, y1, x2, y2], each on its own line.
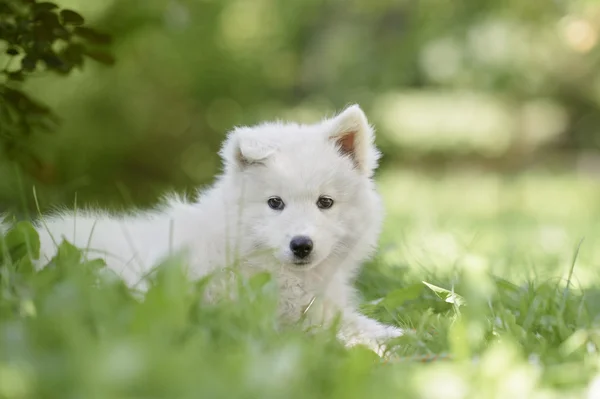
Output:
[0, 171, 600, 399]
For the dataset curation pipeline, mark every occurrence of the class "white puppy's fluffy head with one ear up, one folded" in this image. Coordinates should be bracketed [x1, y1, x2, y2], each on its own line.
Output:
[221, 105, 381, 270]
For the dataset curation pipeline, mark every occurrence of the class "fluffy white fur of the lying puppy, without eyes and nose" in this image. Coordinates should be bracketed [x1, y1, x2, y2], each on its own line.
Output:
[23, 105, 401, 354]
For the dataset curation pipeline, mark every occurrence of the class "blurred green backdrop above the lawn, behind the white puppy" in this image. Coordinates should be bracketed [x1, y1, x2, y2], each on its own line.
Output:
[0, 0, 600, 211]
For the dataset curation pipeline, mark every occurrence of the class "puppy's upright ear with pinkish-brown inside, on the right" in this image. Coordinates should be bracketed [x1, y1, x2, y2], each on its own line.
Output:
[328, 105, 380, 176]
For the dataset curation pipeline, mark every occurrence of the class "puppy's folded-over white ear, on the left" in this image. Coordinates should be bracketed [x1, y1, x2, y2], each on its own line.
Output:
[219, 127, 276, 170]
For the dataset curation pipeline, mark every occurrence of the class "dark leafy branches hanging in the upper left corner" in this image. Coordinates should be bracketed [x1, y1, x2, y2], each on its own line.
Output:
[0, 0, 114, 174]
